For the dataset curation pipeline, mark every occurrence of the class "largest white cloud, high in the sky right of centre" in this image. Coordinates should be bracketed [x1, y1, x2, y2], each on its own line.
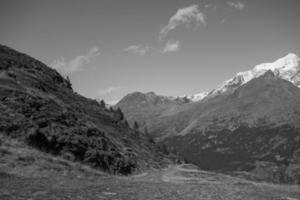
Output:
[160, 5, 206, 39]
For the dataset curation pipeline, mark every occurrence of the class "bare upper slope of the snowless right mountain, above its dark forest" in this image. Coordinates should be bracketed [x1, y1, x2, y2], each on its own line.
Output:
[161, 71, 300, 135]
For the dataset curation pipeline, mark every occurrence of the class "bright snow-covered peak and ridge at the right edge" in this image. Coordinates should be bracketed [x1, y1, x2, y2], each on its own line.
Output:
[210, 53, 300, 95]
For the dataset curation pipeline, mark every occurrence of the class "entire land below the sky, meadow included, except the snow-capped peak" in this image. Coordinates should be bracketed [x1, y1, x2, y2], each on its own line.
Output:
[0, 46, 300, 200]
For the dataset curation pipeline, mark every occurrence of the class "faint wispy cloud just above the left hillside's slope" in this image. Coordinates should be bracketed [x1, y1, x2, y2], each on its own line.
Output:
[50, 47, 100, 74]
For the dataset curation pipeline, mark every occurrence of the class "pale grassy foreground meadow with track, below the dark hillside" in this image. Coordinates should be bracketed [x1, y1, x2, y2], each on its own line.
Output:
[0, 137, 300, 200]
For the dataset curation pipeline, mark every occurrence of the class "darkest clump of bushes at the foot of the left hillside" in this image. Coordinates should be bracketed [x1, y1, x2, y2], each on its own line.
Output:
[27, 124, 137, 174]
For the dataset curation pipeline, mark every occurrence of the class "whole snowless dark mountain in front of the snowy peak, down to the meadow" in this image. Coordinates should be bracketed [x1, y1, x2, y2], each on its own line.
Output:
[164, 71, 300, 183]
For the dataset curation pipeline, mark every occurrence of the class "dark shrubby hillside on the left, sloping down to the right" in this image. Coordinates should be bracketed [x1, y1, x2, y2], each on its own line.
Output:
[0, 45, 168, 174]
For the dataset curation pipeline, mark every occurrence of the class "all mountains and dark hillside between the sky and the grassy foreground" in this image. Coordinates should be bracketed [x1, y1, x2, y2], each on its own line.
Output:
[0, 45, 300, 183]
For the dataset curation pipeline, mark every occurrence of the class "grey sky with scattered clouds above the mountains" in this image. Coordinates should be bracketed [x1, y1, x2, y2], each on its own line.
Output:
[0, 0, 300, 103]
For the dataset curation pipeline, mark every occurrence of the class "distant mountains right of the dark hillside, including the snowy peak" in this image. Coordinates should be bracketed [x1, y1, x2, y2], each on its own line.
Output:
[116, 54, 300, 182]
